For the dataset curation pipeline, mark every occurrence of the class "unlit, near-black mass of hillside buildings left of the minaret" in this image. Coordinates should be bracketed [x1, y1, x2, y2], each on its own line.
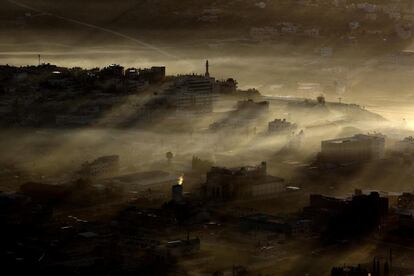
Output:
[0, 64, 166, 126]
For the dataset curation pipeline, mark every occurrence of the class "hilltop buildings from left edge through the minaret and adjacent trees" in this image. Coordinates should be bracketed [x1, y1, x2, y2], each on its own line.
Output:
[0, 61, 259, 127]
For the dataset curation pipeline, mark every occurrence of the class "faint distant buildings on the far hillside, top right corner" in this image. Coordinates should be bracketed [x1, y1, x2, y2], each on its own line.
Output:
[249, 1, 414, 48]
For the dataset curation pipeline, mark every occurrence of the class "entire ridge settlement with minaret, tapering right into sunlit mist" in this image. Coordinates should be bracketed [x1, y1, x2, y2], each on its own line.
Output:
[0, 61, 382, 130]
